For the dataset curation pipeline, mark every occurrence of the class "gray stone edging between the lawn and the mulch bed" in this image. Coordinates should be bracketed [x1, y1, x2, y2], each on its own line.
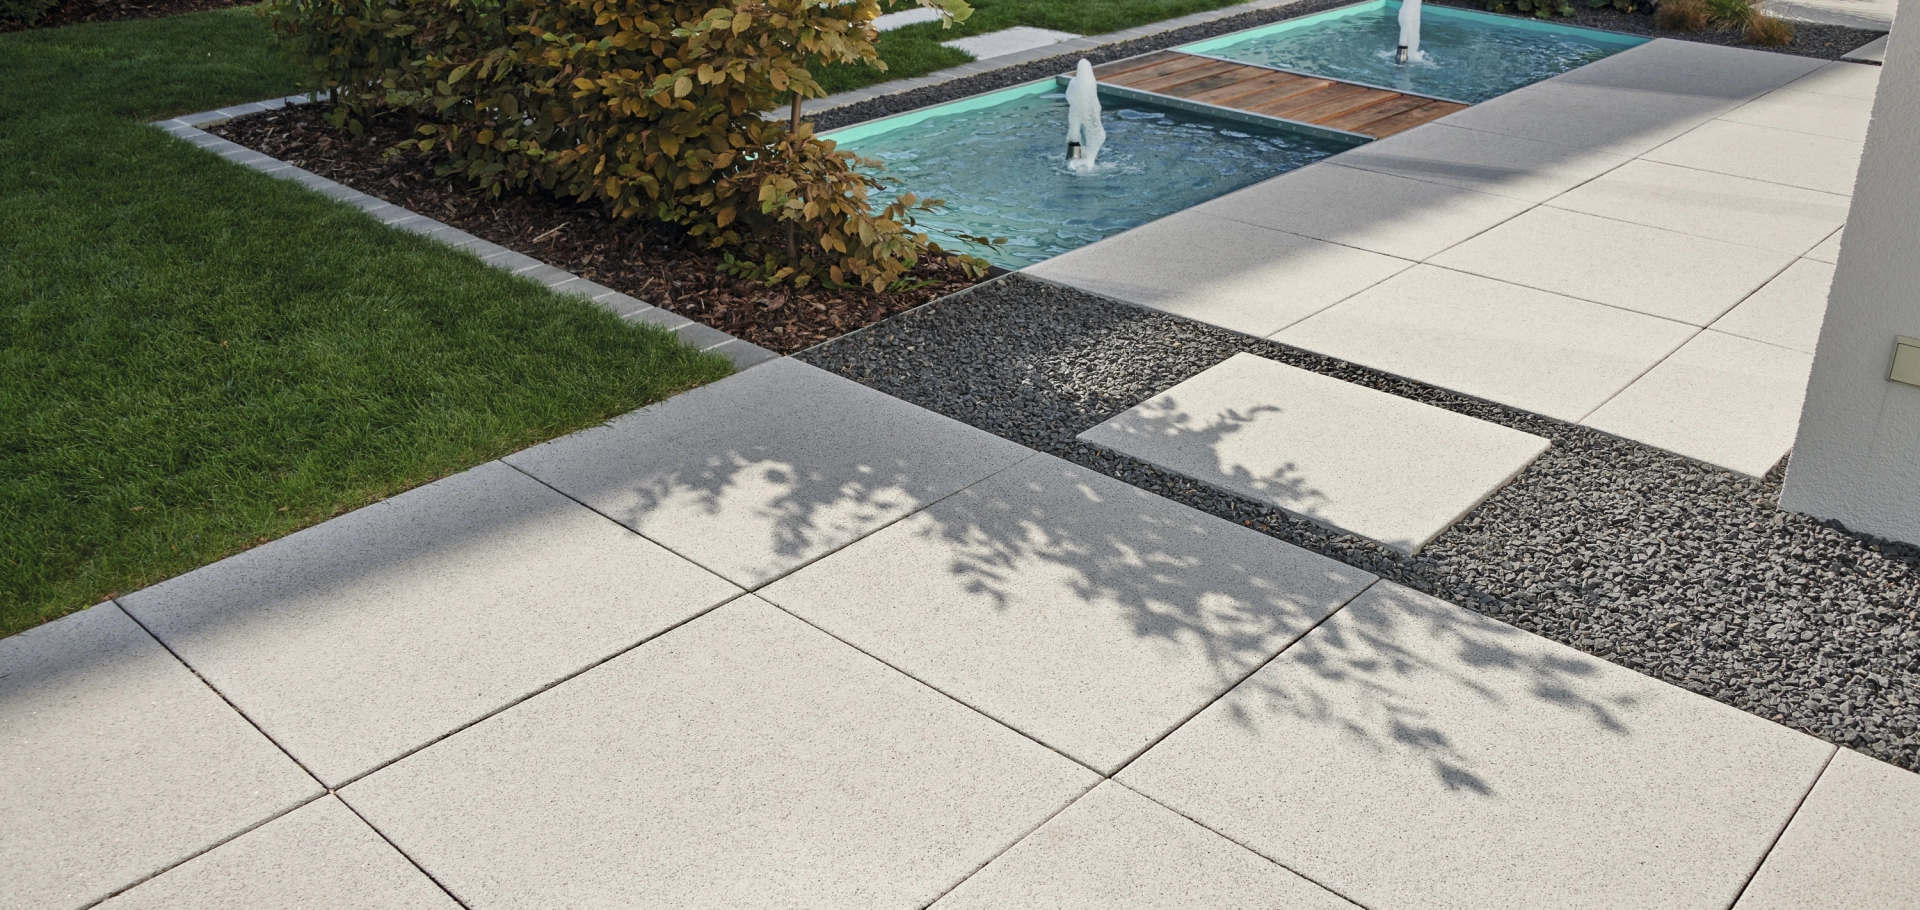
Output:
[154, 94, 780, 371]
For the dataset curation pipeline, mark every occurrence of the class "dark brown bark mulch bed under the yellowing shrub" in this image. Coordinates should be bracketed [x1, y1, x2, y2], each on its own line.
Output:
[209, 104, 973, 353]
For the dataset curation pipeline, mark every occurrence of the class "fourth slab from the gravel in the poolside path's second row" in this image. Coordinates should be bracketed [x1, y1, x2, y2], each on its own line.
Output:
[1645, 121, 1862, 196]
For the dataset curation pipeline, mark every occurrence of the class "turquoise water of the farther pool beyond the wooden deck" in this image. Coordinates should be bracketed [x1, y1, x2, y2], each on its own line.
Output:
[1181, 0, 1645, 104]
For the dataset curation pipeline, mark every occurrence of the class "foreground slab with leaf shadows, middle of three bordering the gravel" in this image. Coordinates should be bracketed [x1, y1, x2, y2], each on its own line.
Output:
[764, 455, 1373, 772]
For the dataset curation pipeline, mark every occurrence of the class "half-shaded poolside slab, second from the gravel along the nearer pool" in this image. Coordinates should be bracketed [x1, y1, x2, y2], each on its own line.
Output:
[1196, 161, 1530, 259]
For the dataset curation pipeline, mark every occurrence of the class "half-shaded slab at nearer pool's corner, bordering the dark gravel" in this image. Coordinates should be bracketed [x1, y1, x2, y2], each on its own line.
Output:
[1023, 211, 1413, 336]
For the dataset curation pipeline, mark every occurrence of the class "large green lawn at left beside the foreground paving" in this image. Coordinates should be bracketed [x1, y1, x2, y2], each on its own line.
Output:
[0, 10, 730, 635]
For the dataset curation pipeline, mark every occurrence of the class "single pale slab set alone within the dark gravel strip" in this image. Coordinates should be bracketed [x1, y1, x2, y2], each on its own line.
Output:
[1079, 353, 1548, 553]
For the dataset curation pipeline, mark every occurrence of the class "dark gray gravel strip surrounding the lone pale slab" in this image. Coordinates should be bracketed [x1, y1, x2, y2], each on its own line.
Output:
[799, 275, 1920, 770]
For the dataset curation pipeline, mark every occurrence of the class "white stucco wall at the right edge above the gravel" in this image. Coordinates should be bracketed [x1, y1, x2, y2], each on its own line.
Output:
[1780, 0, 1920, 543]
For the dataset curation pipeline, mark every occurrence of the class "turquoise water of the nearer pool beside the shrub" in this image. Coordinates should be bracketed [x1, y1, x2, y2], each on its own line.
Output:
[826, 83, 1352, 269]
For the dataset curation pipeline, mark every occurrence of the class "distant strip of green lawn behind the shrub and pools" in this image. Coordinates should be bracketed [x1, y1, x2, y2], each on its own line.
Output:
[816, 0, 1246, 92]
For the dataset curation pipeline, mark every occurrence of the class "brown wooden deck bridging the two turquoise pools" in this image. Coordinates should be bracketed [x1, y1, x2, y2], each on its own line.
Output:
[1094, 50, 1467, 138]
